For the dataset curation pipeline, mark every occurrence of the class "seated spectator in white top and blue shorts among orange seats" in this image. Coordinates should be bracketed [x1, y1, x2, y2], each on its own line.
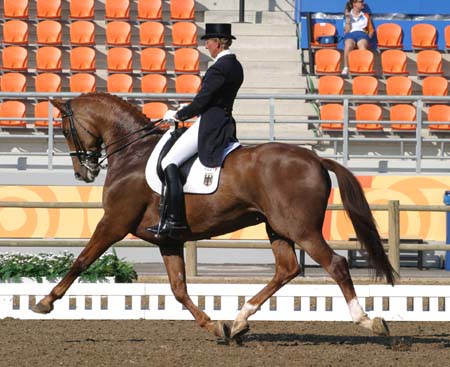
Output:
[342, 0, 375, 75]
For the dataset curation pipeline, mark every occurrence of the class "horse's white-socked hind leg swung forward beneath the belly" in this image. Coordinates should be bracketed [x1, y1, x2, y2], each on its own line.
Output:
[231, 224, 300, 338]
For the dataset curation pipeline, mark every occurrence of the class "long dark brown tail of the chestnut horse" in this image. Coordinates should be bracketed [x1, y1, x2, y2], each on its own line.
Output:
[320, 158, 398, 285]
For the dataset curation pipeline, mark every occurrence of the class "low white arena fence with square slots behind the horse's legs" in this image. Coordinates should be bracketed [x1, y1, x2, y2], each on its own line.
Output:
[0, 283, 450, 321]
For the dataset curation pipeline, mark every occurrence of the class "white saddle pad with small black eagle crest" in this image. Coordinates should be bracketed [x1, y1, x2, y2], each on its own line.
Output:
[145, 129, 240, 194]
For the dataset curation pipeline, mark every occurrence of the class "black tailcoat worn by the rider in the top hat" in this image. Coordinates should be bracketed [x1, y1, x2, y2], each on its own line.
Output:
[177, 54, 244, 167]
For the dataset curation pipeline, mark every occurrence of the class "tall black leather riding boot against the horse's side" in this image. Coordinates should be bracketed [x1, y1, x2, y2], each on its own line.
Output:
[147, 164, 187, 239]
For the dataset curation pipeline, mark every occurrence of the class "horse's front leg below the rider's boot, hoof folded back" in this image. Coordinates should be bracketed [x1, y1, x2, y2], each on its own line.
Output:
[160, 243, 229, 339]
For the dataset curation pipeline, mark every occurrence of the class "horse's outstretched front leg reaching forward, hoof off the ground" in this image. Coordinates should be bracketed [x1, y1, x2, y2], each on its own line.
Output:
[32, 217, 127, 314]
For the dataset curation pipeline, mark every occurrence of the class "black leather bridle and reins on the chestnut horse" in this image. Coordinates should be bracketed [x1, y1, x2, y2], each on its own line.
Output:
[61, 100, 162, 175]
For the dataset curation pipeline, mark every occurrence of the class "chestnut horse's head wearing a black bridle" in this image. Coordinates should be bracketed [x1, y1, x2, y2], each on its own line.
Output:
[50, 99, 102, 182]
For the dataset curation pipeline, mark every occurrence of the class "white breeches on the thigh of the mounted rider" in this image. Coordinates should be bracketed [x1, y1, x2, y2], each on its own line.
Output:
[161, 117, 200, 170]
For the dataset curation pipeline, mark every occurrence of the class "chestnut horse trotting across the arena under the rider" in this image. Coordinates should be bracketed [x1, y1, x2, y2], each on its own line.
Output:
[33, 93, 396, 338]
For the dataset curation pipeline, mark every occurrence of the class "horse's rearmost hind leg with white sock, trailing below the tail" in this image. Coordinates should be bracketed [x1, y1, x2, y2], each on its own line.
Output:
[299, 232, 389, 335]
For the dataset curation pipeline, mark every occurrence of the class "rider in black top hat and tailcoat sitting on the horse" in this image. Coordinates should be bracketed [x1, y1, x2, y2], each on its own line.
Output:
[147, 23, 244, 238]
